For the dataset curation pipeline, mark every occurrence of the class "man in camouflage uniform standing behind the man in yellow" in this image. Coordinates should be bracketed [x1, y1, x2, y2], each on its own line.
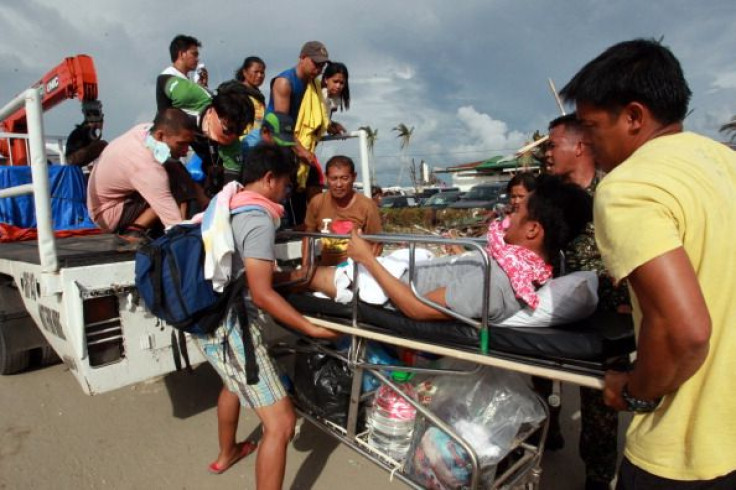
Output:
[535, 114, 630, 490]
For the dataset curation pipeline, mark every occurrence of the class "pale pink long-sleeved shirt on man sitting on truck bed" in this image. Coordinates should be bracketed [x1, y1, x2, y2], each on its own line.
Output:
[87, 124, 182, 231]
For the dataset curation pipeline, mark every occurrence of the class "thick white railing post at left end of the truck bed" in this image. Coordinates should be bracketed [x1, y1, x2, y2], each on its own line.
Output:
[0, 88, 59, 273]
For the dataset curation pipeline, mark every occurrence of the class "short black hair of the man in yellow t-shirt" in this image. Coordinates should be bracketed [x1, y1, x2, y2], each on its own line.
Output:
[560, 39, 692, 124]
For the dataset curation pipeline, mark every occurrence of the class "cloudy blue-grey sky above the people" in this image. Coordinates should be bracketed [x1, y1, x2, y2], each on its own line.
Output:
[0, 0, 736, 185]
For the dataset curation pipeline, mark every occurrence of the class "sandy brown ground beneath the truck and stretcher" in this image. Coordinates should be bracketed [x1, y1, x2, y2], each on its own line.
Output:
[0, 358, 628, 490]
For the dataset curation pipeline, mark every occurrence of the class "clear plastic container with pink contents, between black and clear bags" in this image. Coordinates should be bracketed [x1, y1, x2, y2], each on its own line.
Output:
[368, 371, 417, 461]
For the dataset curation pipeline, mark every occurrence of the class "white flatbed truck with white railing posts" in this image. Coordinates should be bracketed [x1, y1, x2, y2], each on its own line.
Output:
[0, 89, 370, 395]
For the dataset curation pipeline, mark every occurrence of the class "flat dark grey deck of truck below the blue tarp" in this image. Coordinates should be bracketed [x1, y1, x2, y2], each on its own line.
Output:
[0, 234, 135, 267]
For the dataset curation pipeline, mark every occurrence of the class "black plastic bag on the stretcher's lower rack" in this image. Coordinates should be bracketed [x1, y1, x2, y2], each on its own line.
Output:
[294, 352, 353, 427]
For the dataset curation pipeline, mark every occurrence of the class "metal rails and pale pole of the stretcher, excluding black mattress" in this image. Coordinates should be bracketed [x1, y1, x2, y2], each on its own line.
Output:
[276, 232, 632, 489]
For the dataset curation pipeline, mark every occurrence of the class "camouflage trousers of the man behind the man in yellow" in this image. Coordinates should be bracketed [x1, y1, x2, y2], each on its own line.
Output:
[532, 377, 618, 482]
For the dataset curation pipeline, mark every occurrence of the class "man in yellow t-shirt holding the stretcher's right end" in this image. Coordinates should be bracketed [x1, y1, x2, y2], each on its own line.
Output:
[562, 40, 736, 490]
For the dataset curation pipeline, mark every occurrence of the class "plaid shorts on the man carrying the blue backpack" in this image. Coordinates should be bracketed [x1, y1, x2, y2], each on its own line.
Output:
[193, 311, 287, 408]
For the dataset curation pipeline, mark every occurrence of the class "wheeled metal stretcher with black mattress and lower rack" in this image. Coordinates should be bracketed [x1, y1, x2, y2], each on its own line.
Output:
[273, 233, 635, 489]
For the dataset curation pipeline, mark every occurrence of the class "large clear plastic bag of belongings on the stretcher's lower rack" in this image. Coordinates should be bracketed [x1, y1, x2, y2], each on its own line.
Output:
[407, 368, 545, 490]
